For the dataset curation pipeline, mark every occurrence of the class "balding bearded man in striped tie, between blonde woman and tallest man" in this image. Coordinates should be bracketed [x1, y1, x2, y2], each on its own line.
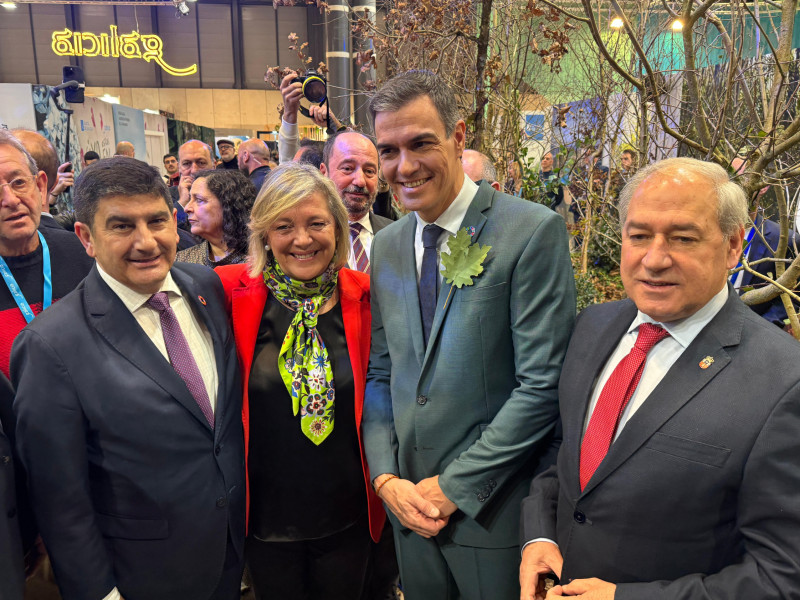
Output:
[319, 131, 392, 273]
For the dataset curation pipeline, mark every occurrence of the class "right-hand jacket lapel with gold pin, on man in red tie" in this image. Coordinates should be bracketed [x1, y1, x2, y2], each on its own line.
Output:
[583, 285, 749, 494]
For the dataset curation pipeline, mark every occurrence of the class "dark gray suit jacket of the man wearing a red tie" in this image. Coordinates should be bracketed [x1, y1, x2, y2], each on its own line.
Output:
[522, 286, 800, 600]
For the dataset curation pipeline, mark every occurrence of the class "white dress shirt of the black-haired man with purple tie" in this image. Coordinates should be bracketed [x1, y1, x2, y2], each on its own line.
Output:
[97, 263, 217, 600]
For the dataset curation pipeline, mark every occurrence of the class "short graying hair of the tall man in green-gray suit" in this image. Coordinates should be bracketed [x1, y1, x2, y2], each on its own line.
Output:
[369, 69, 460, 136]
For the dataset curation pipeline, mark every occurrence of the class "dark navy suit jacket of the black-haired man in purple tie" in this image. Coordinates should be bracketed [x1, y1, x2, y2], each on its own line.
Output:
[11, 263, 245, 600]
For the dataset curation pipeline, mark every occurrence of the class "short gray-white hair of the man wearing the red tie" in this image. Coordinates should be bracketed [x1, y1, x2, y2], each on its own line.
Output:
[618, 157, 747, 238]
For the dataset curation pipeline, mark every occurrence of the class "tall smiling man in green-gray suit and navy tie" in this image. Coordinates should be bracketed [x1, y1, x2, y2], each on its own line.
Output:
[363, 71, 575, 600]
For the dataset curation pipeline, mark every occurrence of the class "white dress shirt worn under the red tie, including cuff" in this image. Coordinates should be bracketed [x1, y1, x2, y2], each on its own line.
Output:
[522, 281, 728, 550]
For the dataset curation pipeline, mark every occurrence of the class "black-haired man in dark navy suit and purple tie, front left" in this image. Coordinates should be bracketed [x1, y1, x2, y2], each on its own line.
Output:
[12, 157, 245, 600]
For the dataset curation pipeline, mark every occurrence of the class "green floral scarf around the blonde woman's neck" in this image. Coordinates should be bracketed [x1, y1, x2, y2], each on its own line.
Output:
[264, 260, 338, 446]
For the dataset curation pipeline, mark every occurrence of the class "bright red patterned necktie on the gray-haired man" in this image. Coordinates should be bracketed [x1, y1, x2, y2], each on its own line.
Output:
[580, 323, 669, 491]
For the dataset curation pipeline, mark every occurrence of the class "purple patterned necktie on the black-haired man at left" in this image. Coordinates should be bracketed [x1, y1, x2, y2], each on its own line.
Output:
[147, 292, 214, 428]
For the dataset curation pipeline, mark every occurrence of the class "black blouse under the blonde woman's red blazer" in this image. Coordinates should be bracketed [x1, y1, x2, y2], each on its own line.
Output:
[248, 295, 366, 542]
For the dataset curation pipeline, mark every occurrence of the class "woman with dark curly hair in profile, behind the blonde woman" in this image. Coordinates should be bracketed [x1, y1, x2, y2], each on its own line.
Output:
[176, 169, 256, 268]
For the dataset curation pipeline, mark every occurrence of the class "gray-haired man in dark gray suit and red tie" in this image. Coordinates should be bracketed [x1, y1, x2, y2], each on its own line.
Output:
[520, 158, 800, 600]
